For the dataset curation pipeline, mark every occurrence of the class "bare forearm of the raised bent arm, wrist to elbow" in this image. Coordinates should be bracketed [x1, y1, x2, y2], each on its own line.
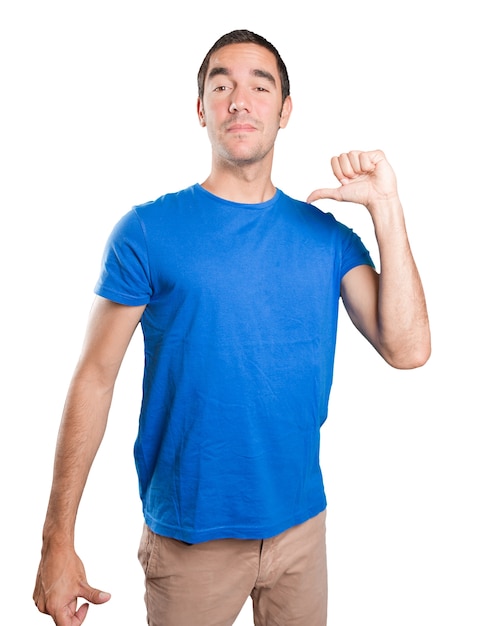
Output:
[370, 198, 430, 368]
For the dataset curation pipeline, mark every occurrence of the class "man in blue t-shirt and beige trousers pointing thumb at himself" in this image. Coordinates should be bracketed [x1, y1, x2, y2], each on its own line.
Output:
[34, 31, 430, 626]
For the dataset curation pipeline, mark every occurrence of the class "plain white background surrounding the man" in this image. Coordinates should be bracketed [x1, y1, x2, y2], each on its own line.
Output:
[0, 0, 486, 626]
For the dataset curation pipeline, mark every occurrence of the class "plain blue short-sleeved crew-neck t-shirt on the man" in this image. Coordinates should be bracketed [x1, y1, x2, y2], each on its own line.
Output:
[95, 184, 372, 543]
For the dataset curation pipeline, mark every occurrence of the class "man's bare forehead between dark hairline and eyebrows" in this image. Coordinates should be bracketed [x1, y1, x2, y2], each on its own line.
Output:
[206, 43, 279, 83]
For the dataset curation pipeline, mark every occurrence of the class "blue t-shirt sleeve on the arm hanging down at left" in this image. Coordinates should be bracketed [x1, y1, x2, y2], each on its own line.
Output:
[94, 210, 152, 306]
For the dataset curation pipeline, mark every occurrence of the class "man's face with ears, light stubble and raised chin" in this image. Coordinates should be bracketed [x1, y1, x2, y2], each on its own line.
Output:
[198, 43, 292, 165]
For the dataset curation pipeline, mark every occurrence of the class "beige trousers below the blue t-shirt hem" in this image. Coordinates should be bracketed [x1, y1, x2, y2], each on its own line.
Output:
[139, 511, 327, 626]
